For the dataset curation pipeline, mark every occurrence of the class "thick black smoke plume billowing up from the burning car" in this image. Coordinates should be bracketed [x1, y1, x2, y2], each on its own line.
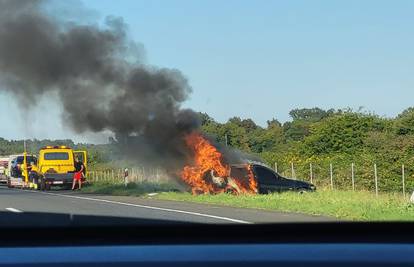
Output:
[0, 0, 198, 171]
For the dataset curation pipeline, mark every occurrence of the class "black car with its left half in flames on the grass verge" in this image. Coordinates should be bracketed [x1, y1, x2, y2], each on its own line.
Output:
[180, 133, 316, 194]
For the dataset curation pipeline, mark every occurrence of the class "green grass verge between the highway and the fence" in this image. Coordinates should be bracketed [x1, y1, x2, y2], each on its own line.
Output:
[83, 183, 414, 221]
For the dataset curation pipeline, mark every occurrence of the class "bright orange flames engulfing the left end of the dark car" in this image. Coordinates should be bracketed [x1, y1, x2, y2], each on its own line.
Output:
[181, 132, 257, 194]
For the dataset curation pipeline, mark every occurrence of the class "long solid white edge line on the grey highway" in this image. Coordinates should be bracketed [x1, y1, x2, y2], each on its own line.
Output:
[34, 191, 253, 224]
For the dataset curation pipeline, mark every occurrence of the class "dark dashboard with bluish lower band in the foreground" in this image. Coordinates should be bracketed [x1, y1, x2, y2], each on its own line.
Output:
[0, 217, 414, 267]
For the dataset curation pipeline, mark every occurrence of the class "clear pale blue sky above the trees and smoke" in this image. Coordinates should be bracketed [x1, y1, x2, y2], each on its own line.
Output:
[0, 0, 414, 142]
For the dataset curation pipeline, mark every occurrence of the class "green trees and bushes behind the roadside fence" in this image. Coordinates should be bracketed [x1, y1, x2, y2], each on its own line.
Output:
[0, 107, 414, 193]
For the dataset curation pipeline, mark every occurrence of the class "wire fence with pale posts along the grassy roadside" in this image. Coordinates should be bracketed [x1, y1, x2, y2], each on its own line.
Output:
[87, 162, 414, 197]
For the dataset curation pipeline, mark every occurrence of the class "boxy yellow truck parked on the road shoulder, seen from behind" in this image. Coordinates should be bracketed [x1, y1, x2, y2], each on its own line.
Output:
[37, 146, 87, 190]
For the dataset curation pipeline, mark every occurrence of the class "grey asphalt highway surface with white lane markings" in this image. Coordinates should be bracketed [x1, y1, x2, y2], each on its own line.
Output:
[0, 187, 333, 225]
